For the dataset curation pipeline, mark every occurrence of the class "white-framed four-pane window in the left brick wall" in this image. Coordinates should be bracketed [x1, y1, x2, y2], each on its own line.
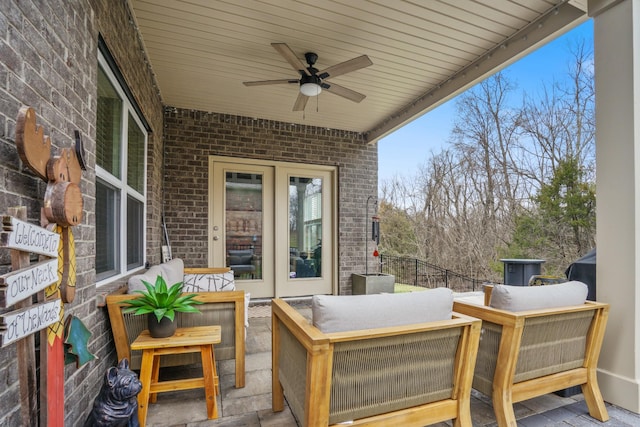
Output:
[96, 52, 147, 281]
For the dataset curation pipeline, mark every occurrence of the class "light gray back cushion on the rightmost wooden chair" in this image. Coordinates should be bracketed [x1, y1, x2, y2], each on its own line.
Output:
[489, 280, 589, 311]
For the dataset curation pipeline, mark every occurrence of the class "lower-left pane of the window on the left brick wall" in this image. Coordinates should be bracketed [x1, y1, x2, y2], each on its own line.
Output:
[96, 179, 120, 280]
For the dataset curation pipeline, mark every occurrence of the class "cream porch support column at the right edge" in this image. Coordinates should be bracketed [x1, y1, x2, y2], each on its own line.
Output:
[588, 0, 640, 413]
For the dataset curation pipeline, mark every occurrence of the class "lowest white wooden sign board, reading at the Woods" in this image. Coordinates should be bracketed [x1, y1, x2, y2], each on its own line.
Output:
[0, 298, 62, 347]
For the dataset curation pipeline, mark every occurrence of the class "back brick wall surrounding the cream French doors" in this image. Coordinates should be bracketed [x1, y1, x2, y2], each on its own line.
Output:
[165, 108, 378, 294]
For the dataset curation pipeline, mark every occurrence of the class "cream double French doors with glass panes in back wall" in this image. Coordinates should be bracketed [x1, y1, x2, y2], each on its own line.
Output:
[209, 156, 337, 298]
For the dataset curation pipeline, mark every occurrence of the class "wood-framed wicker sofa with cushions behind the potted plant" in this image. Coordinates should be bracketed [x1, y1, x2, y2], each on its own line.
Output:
[106, 260, 248, 388]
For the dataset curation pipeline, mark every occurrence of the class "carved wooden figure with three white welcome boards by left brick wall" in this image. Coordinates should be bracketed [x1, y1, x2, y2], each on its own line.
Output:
[0, 107, 85, 427]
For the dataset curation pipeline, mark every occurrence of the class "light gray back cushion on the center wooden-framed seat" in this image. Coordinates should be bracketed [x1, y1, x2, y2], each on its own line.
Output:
[311, 288, 453, 333]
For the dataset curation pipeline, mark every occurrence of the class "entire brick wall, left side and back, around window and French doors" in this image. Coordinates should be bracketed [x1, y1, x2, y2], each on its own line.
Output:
[0, 0, 377, 426]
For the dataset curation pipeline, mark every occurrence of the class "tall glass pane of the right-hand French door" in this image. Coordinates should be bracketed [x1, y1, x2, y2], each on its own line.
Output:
[289, 176, 322, 278]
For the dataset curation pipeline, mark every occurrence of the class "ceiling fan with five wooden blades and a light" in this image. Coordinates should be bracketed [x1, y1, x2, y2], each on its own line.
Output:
[243, 43, 373, 111]
